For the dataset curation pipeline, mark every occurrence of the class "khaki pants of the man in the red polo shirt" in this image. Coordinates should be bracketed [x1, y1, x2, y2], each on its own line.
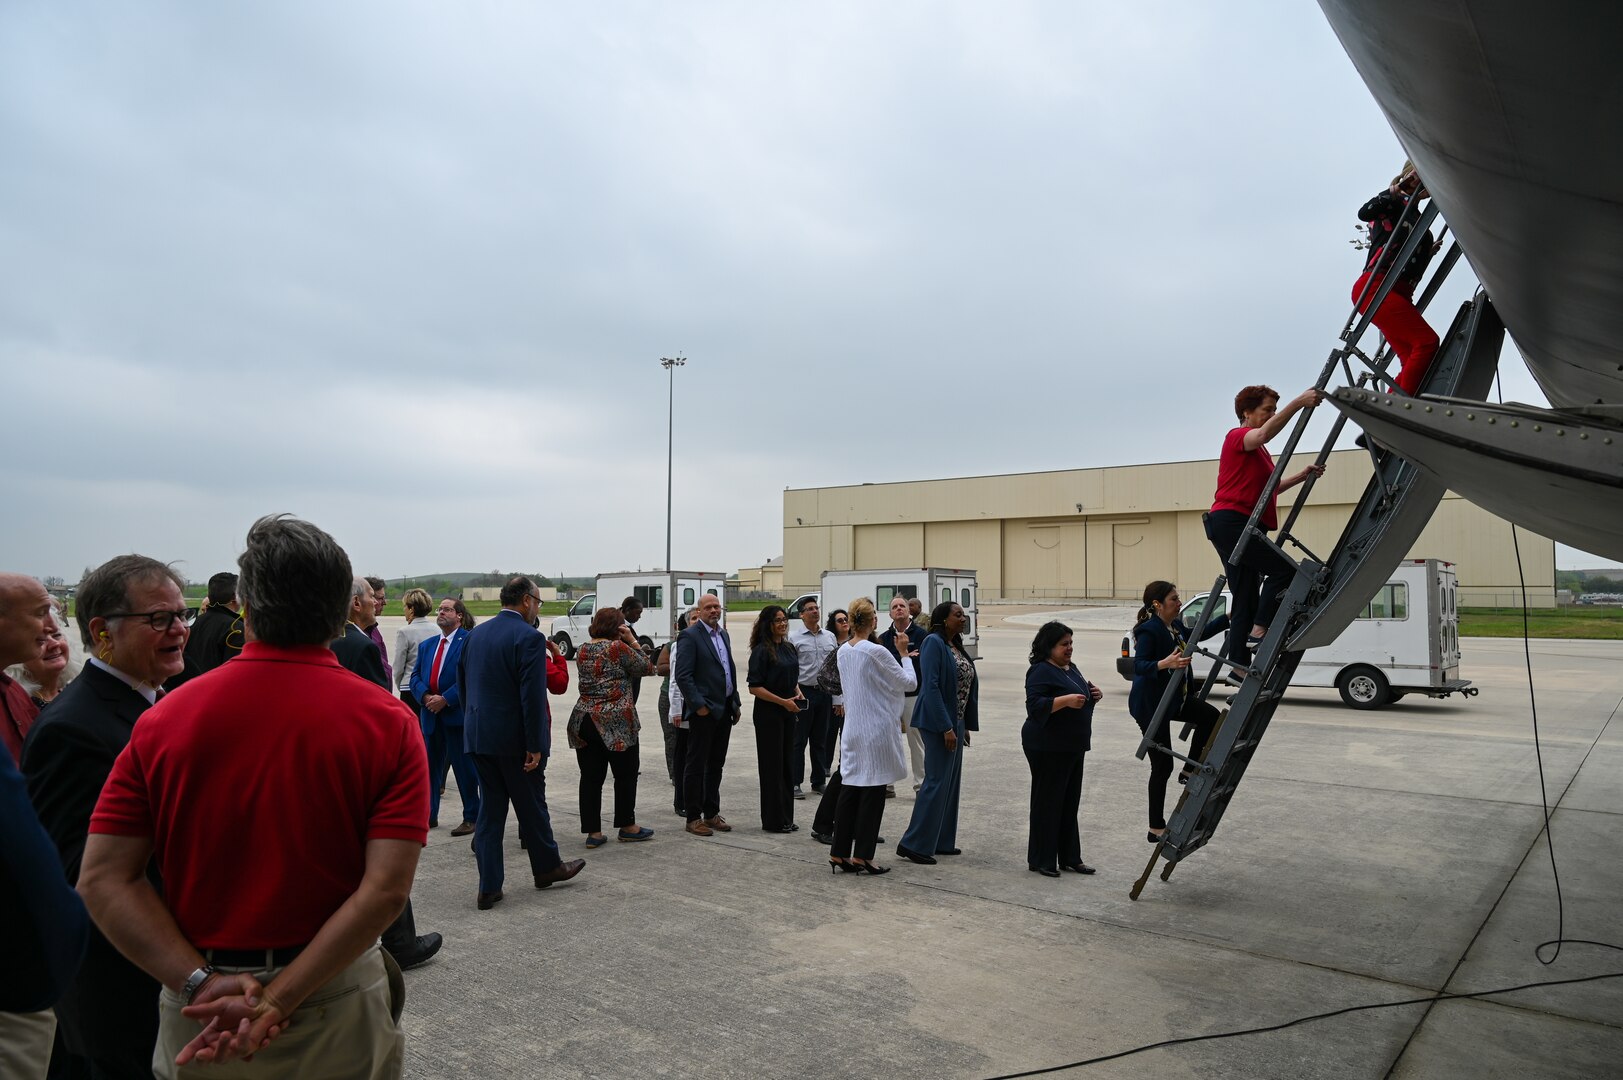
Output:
[153, 945, 406, 1080]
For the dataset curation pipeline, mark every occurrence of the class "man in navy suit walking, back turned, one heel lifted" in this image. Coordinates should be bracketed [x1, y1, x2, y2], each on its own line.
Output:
[456, 575, 586, 911]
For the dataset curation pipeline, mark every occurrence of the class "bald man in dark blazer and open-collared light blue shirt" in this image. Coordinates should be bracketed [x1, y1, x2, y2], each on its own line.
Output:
[675, 593, 742, 836]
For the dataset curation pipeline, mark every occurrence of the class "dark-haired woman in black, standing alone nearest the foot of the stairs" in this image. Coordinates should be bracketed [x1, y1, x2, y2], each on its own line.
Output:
[1019, 622, 1104, 877]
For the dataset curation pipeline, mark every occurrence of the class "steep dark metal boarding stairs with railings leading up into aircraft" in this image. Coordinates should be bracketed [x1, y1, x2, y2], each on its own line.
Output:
[1130, 203, 1505, 900]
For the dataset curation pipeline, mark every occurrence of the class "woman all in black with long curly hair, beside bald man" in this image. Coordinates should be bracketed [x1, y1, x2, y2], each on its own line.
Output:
[748, 604, 805, 833]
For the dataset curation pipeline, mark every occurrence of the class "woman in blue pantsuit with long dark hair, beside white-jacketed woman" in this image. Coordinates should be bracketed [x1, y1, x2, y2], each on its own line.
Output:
[896, 601, 980, 864]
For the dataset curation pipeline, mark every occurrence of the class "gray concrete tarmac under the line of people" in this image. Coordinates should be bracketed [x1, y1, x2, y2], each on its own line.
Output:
[385, 607, 1623, 1080]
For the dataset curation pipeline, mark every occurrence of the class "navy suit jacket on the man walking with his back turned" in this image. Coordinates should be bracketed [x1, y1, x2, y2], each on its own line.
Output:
[457, 607, 552, 757]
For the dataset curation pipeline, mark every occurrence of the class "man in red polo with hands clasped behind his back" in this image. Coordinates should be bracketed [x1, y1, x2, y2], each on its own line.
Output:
[80, 516, 428, 1078]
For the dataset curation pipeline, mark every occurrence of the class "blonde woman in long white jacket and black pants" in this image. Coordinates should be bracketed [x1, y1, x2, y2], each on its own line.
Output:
[828, 596, 919, 874]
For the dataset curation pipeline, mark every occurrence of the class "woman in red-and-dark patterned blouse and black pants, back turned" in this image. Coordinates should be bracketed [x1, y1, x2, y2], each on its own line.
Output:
[568, 607, 654, 848]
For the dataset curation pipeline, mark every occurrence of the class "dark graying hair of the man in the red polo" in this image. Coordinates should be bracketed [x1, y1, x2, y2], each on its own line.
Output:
[237, 513, 355, 646]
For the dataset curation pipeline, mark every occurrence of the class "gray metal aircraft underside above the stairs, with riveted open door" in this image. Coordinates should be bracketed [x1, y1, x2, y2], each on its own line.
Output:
[1319, 0, 1623, 559]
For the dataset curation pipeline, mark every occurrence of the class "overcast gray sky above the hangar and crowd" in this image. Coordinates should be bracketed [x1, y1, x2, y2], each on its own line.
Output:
[0, 0, 1599, 580]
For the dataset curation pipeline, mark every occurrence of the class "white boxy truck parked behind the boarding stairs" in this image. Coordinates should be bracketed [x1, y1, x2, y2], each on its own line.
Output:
[1182, 559, 1477, 708]
